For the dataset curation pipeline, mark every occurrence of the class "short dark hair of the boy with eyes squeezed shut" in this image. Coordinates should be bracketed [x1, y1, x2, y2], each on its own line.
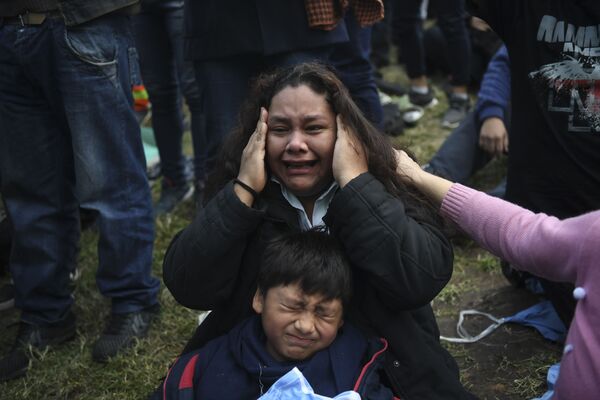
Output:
[258, 229, 352, 305]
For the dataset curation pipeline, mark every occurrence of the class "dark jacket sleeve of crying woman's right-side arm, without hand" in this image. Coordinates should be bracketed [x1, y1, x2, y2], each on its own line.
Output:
[325, 172, 453, 309]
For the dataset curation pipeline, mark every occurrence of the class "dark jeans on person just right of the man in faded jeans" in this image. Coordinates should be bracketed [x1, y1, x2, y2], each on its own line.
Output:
[134, 7, 206, 186]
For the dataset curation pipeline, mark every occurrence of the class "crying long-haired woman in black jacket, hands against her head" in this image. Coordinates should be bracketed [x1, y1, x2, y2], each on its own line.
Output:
[163, 63, 471, 399]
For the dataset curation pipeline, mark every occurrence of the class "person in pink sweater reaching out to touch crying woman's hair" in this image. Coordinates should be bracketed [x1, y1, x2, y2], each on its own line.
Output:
[398, 148, 600, 400]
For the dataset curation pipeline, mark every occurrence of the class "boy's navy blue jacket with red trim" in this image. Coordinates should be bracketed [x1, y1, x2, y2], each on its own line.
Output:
[162, 316, 393, 400]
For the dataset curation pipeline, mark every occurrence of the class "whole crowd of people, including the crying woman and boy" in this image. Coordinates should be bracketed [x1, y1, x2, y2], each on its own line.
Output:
[0, 0, 600, 399]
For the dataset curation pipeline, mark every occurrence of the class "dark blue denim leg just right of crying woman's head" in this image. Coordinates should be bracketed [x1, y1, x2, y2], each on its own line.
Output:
[330, 12, 383, 129]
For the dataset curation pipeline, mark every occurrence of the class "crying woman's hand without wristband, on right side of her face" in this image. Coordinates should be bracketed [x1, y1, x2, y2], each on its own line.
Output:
[332, 115, 369, 187]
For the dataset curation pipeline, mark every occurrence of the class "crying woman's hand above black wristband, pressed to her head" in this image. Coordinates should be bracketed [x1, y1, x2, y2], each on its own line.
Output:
[234, 107, 268, 207]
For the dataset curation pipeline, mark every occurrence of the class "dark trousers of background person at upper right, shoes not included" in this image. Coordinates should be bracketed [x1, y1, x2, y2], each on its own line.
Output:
[392, 0, 471, 86]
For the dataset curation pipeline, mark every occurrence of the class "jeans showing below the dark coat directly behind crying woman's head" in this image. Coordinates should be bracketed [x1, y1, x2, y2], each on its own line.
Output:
[194, 46, 331, 173]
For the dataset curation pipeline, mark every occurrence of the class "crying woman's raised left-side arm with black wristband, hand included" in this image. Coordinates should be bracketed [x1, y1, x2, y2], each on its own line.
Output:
[163, 108, 268, 310]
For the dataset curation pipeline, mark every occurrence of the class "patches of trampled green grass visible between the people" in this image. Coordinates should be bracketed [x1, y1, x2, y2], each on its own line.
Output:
[0, 67, 560, 400]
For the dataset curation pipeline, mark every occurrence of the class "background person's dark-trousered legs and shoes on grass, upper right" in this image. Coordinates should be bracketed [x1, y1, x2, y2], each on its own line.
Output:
[392, 0, 471, 129]
